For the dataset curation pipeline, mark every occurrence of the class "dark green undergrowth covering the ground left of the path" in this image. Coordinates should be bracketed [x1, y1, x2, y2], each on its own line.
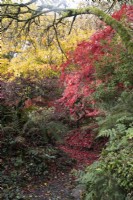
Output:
[0, 106, 72, 200]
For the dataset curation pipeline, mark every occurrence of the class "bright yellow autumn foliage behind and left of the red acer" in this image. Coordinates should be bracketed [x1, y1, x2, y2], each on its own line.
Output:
[1, 16, 94, 77]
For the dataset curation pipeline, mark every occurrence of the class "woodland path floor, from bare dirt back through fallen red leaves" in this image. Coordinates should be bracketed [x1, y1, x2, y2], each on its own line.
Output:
[21, 130, 105, 200]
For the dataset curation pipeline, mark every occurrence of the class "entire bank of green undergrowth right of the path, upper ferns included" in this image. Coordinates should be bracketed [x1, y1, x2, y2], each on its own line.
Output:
[80, 91, 133, 200]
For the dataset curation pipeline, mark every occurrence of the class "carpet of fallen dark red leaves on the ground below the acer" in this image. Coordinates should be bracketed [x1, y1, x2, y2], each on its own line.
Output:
[59, 130, 106, 164]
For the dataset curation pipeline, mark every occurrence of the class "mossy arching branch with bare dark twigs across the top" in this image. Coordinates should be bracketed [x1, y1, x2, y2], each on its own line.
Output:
[0, 0, 133, 51]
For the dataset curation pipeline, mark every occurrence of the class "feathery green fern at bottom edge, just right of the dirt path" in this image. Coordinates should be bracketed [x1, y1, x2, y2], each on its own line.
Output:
[81, 162, 126, 200]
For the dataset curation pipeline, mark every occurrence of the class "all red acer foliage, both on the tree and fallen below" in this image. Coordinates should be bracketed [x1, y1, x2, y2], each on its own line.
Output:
[58, 5, 133, 164]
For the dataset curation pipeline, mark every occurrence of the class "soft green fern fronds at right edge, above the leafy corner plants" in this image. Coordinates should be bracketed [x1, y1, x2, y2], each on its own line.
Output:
[97, 91, 133, 132]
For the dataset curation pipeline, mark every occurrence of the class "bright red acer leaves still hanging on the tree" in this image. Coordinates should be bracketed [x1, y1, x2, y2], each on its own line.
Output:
[58, 5, 133, 120]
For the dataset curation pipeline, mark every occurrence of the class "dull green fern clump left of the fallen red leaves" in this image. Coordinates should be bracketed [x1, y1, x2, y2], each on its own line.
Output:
[22, 108, 68, 144]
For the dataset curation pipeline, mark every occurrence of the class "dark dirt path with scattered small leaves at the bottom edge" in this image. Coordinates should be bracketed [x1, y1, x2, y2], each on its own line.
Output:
[22, 169, 80, 200]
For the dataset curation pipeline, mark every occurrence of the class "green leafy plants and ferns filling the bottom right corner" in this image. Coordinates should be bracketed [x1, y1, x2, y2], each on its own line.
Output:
[80, 124, 133, 200]
